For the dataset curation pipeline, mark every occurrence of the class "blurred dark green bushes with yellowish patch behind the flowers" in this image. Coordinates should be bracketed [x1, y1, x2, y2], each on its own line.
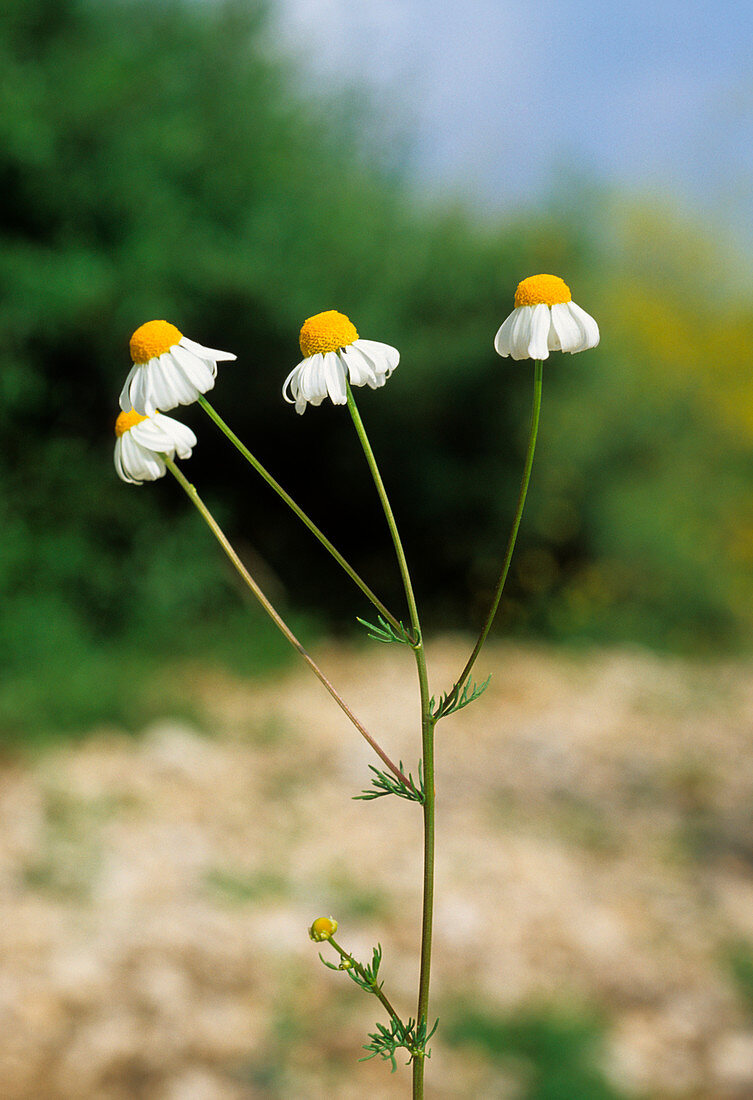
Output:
[0, 0, 753, 737]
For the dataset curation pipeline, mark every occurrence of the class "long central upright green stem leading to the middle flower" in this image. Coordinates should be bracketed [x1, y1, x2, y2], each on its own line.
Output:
[347, 384, 435, 1100]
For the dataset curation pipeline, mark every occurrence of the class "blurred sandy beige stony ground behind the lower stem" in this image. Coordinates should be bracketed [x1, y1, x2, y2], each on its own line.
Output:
[0, 639, 753, 1100]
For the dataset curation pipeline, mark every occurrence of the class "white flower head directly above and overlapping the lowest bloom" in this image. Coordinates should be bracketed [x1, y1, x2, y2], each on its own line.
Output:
[120, 321, 235, 416]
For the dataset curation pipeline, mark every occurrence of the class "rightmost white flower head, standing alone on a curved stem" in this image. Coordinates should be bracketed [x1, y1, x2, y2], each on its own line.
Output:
[495, 275, 599, 359]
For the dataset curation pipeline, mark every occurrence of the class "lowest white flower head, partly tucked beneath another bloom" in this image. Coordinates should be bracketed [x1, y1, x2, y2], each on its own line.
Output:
[114, 409, 196, 485]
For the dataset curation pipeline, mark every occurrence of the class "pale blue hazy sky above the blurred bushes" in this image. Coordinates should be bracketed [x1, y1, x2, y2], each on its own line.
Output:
[276, 0, 753, 227]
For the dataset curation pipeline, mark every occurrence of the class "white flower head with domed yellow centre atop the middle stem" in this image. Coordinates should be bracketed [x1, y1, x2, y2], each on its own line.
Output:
[283, 309, 400, 413]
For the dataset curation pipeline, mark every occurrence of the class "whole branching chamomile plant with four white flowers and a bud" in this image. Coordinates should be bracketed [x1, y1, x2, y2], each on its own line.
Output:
[114, 275, 599, 1100]
